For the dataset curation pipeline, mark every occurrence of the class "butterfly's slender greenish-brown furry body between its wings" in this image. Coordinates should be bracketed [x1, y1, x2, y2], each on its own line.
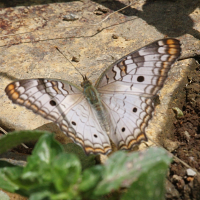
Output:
[81, 78, 110, 133]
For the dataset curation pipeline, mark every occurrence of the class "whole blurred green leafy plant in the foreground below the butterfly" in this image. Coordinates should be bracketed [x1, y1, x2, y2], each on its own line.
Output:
[0, 131, 171, 200]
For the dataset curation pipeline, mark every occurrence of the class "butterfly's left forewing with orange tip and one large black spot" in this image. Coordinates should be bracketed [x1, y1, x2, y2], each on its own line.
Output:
[5, 79, 83, 121]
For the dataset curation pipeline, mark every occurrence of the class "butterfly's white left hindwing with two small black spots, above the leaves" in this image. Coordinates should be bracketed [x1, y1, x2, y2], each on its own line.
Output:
[59, 99, 111, 154]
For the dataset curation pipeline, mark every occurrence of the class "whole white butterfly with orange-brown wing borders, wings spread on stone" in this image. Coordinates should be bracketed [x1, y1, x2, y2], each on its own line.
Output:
[5, 38, 181, 154]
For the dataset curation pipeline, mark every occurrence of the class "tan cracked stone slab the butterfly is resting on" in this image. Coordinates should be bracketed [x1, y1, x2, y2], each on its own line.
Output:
[0, 0, 200, 146]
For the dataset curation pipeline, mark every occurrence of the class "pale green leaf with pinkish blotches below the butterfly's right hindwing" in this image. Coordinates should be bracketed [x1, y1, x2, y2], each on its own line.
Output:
[94, 148, 171, 195]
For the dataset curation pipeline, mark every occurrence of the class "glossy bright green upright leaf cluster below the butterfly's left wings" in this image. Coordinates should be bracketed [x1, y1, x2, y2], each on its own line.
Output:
[21, 134, 81, 199]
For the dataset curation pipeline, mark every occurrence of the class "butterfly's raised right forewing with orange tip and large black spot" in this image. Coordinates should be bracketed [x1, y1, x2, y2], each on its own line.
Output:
[96, 39, 181, 97]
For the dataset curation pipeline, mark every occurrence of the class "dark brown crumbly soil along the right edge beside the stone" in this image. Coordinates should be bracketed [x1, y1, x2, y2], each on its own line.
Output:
[166, 57, 200, 200]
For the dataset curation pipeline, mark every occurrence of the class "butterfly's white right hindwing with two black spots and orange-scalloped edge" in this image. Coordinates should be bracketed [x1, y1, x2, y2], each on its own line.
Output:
[101, 93, 153, 149]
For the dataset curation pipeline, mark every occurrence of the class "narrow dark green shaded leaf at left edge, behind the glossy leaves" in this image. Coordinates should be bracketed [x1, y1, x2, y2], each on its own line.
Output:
[0, 130, 48, 154]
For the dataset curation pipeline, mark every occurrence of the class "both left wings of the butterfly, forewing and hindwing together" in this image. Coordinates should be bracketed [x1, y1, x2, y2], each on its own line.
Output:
[5, 79, 111, 154]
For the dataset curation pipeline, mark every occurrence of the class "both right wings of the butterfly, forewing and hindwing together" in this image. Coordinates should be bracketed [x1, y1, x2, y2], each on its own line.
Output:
[95, 39, 181, 149]
